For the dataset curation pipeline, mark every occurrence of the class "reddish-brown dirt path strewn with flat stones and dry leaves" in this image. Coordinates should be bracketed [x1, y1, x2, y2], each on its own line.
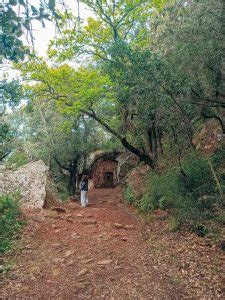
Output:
[2, 188, 221, 299]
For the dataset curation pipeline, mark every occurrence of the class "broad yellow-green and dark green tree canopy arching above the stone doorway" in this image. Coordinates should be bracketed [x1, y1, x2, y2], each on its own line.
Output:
[1, 0, 225, 200]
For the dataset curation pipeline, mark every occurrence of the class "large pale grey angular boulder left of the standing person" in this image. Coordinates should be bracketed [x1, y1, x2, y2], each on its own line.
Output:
[0, 160, 59, 209]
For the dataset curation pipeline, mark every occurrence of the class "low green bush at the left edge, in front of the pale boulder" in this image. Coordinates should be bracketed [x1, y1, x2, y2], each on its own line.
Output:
[0, 193, 23, 253]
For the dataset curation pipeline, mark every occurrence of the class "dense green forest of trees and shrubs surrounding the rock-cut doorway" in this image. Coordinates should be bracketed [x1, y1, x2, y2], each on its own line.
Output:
[0, 0, 225, 296]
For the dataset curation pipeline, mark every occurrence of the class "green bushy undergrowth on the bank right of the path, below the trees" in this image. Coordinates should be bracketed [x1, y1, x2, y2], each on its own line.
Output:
[125, 151, 225, 236]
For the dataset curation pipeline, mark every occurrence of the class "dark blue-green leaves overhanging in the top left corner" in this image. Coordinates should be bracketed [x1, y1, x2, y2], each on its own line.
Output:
[0, 0, 60, 62]
